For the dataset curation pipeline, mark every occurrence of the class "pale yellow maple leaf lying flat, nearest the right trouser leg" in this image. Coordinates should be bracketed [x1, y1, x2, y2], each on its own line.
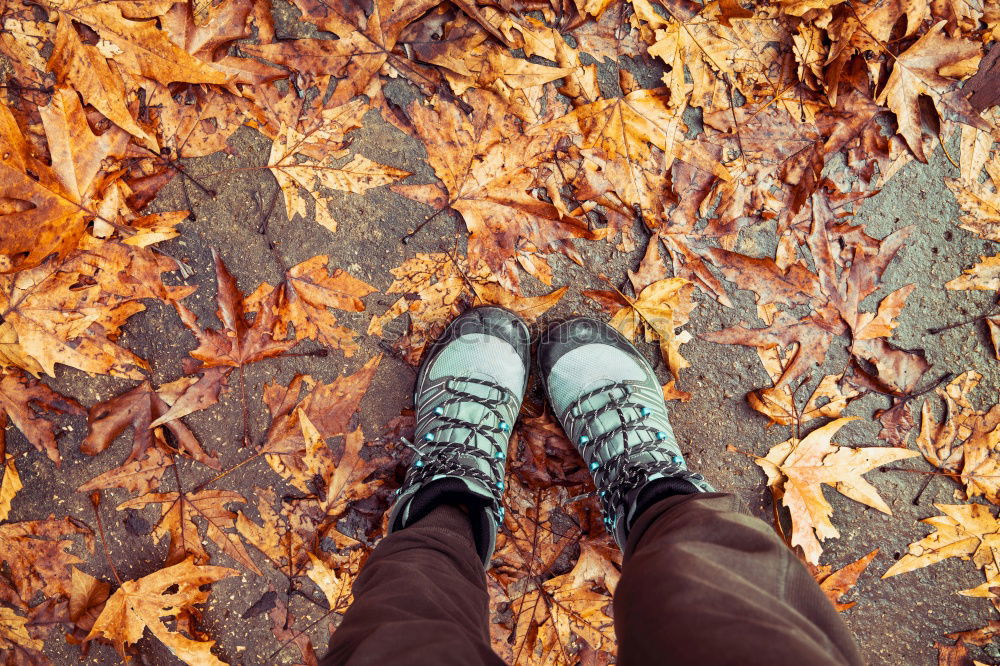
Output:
[754, 417, 919, 564]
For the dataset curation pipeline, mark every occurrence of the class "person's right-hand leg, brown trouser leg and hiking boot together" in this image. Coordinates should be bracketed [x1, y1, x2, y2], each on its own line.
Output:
[538, 317, 861, 666]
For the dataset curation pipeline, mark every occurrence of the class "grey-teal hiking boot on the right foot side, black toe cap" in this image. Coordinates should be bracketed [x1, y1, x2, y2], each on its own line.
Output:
[537, 317, 713, 549]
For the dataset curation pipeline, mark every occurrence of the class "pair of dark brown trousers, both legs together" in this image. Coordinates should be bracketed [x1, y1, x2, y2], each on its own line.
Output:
[322, 493, 862, 666]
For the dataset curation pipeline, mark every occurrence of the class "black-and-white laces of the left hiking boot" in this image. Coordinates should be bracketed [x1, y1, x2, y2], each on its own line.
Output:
[404, 377, 514, 520]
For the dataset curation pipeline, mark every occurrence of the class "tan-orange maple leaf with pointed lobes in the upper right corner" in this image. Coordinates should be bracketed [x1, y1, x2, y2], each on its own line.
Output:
[877, 21, 989, 162]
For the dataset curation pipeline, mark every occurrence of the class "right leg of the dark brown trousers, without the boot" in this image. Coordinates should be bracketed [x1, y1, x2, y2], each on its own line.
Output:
[614, 493, 863, 666]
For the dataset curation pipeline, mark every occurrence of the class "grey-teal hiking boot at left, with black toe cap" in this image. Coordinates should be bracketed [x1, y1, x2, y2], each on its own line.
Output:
[389, 306, 531, 565]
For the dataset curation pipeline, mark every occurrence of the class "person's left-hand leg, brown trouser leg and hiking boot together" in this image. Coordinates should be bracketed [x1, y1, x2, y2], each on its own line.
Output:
[323, 307, 530, 666]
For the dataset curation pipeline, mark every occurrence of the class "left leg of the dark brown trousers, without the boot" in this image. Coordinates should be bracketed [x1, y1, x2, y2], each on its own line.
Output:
[322, 504, 503, 666]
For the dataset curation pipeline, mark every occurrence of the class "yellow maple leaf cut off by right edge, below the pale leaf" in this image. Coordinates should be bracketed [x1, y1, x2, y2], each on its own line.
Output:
[882, 504, 1000, 596]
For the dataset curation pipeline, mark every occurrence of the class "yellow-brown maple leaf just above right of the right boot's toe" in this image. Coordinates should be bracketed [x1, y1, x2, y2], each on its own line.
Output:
[584, 278, 695, 379]
